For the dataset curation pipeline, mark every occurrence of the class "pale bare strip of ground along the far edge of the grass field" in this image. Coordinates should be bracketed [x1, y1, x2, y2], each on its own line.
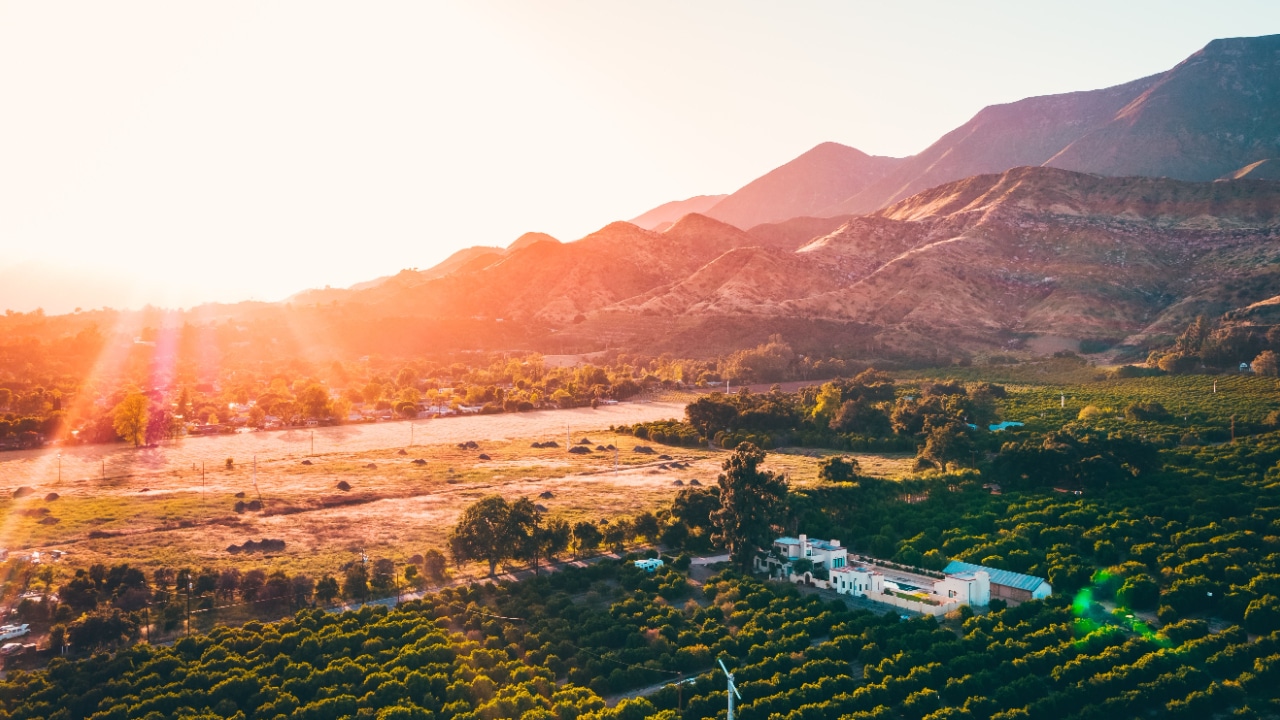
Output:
[0, 402, 685, 487]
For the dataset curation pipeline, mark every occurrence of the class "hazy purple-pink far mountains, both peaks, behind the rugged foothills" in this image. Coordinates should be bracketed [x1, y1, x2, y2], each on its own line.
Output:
[640, 35, 1280, 222]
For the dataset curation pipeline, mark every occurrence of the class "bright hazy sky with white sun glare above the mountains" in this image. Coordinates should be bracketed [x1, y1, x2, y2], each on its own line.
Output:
[0, 0, 1280, 313]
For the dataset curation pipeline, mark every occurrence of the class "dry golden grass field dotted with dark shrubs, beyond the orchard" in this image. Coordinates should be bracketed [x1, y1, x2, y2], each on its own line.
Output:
[0, 406, 910, 575]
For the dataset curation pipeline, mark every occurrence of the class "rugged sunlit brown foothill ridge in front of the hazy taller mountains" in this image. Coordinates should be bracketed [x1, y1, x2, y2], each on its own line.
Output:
[304, 168, 1280, 352]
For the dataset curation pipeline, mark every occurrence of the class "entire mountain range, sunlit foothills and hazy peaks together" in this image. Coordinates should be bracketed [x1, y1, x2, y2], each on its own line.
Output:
[47, 36, 1280, 355]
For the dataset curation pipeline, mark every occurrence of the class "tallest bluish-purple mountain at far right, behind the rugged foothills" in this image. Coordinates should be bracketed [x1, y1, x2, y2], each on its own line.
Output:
[824, 35, 1280, 215]
